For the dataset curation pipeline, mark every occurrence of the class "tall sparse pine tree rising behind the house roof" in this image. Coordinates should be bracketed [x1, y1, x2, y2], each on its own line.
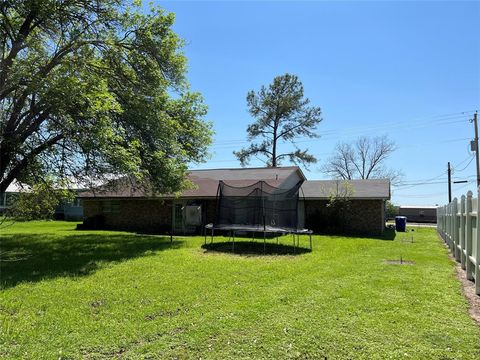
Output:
[234, 73, 322, 167]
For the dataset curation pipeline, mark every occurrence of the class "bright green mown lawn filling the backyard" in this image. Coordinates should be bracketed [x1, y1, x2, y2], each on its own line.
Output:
[0, 222, 480, 359]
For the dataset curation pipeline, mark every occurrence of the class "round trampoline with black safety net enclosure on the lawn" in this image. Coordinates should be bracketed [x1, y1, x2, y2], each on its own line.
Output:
[205, 181, 312, 252]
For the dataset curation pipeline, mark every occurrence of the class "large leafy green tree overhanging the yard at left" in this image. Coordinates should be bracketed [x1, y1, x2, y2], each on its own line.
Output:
[0, 0, 211, 192]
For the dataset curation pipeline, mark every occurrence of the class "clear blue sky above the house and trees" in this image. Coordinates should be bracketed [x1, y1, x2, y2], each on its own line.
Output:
[158, 1, 480, 205]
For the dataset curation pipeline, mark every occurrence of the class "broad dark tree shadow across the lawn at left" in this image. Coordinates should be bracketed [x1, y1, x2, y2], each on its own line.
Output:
[0, 233, 181, 288]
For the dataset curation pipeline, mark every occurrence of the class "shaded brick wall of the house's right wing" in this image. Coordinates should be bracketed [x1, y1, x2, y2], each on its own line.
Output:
[305, 200, 385, 235]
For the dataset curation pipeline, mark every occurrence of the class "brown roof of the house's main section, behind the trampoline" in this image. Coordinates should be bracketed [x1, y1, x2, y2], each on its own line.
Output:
[79, 166, 305, 198]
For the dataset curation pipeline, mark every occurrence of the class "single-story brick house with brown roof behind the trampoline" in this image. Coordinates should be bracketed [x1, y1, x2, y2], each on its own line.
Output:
[79, 166, 390, 234]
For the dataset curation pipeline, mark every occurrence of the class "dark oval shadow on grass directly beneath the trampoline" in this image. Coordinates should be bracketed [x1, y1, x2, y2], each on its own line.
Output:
[202, 240, 311, 255]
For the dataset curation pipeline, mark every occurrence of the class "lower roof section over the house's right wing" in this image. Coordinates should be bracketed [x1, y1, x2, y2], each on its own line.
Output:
[301, 179, 390, 200]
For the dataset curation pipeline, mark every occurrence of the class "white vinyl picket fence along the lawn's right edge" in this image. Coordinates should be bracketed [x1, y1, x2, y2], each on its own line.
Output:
[437, 191, 480, 295]
